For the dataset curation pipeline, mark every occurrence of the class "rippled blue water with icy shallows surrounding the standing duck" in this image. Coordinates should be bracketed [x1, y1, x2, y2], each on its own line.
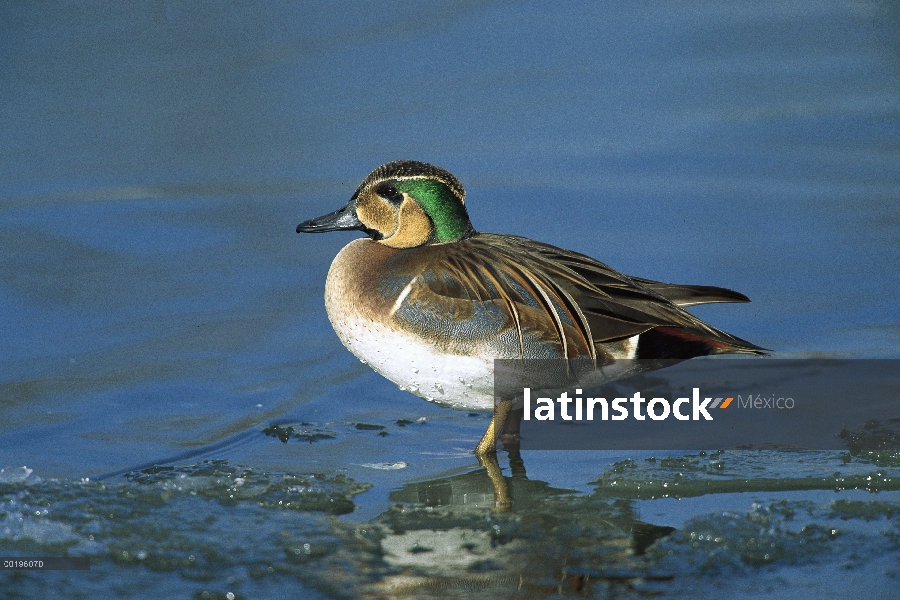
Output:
[0, 1, 900, 598]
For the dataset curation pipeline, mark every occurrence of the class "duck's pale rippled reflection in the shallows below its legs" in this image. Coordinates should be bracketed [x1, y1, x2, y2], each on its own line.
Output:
[375, 451, 674, 597]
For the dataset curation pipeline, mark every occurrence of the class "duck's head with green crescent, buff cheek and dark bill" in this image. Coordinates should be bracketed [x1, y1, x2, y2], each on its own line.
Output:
[297, 160, 475, 248]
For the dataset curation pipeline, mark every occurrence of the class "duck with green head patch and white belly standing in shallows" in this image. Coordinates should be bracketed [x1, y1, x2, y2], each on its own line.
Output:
[297, 161, 764, 456]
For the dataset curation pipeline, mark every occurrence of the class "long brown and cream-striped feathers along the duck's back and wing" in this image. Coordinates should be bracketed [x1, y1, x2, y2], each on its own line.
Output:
[408, 233, 762, 358]
